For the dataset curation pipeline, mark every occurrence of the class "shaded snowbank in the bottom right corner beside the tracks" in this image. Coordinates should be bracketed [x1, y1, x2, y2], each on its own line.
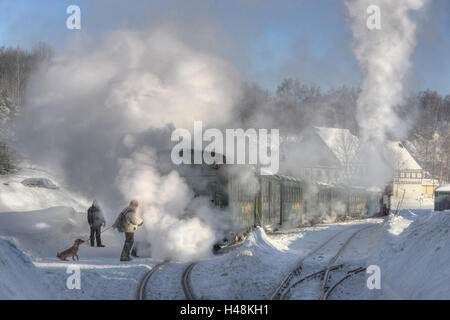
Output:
[368, 210, 450, 299]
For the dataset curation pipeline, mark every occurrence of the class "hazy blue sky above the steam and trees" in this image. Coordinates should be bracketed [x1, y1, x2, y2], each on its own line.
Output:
[0, 0, 450, 94]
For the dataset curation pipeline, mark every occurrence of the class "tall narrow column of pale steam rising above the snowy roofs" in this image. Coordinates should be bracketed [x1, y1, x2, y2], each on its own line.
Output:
[346, 0, 427, 185]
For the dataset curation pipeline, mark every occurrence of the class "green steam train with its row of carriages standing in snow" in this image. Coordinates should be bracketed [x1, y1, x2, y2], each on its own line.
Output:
[174, 150, 382, 242]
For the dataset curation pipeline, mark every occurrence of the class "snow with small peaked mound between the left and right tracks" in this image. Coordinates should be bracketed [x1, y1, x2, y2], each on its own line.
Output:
[192, 219, 380, 299]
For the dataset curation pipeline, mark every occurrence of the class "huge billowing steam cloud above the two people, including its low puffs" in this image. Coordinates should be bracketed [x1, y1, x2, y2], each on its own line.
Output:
[17, 28, 240, 260]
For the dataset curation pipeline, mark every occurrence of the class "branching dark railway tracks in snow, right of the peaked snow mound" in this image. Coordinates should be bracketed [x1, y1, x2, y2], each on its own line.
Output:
[269, 226, 372, 300]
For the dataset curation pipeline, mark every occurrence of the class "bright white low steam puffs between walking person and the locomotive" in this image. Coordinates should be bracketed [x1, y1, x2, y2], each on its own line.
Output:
[116, 147, 228, 260]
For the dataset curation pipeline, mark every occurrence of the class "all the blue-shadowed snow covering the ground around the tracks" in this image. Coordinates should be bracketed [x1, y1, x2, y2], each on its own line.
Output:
[0, 169, 450, 299]
